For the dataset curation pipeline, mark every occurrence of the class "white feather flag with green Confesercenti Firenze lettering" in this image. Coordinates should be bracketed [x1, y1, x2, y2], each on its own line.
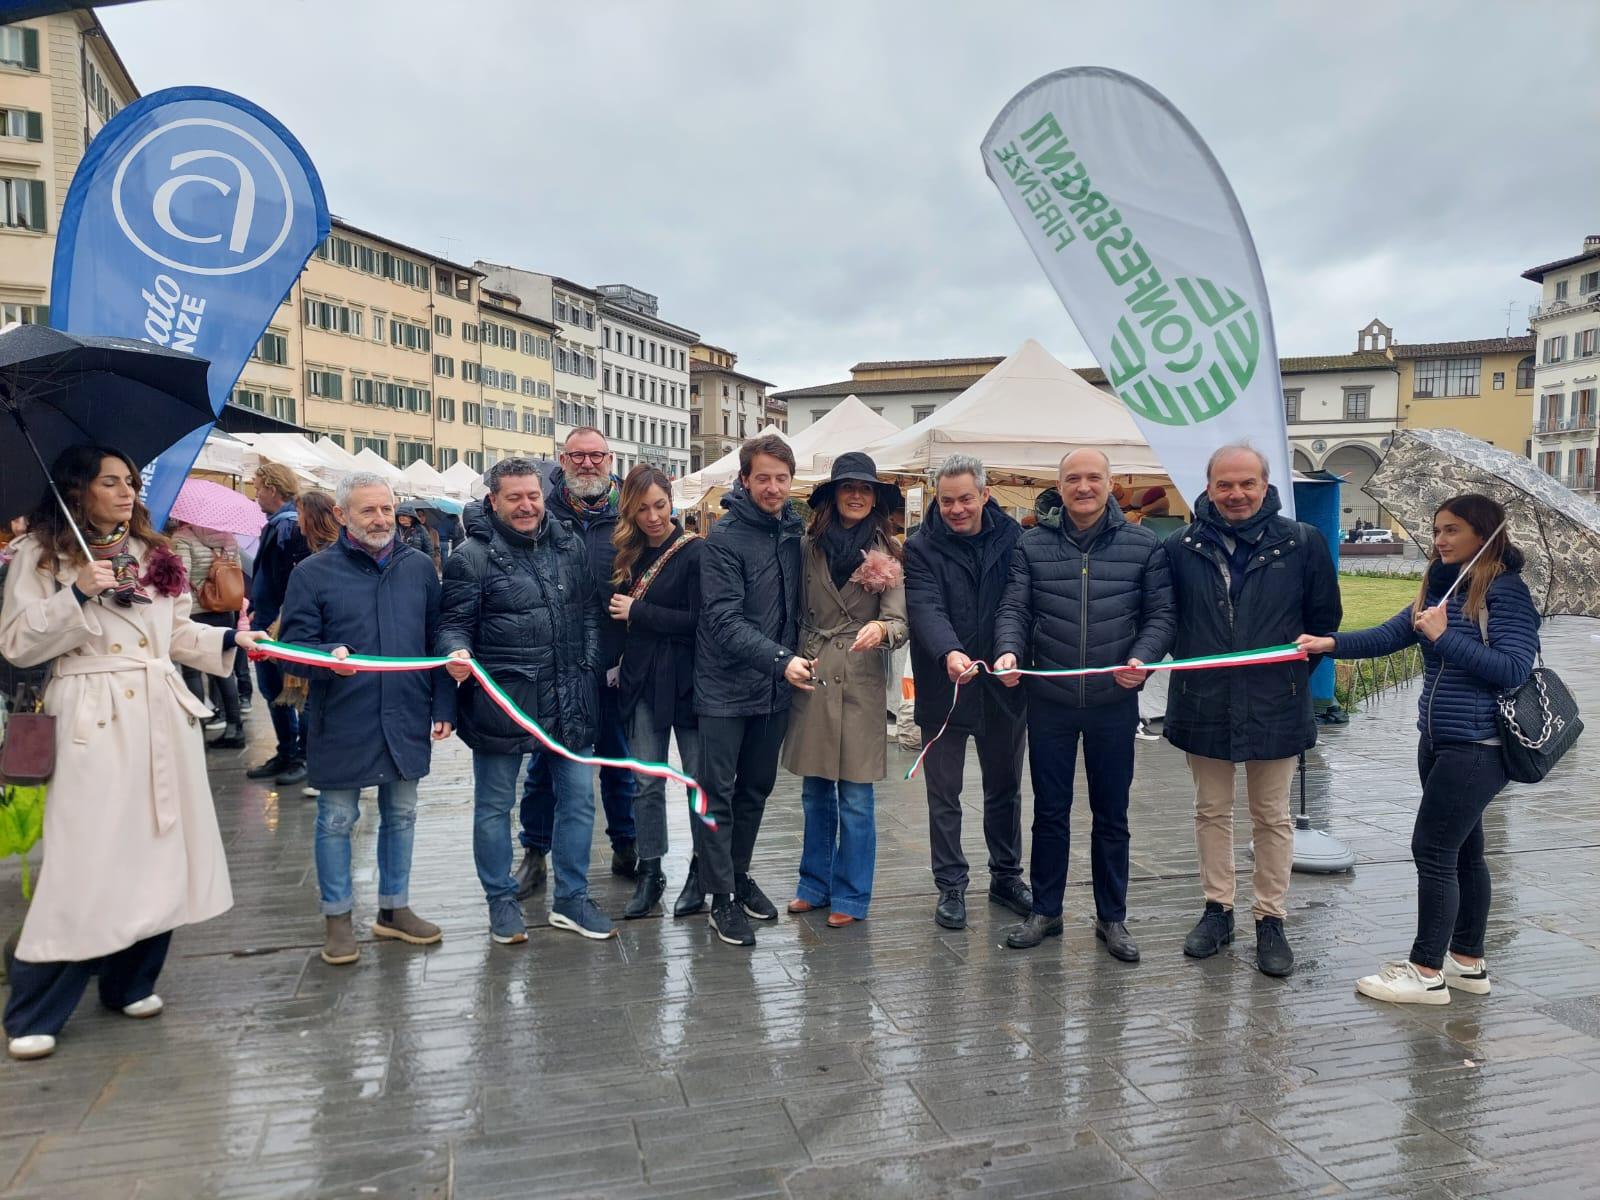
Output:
[982, 67, 1294, 515]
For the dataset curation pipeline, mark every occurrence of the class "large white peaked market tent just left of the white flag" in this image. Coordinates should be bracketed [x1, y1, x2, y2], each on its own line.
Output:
[844, 338, 1166, 483]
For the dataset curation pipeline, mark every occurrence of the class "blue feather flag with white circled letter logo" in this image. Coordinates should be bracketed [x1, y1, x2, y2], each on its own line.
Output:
[50, 80, 328, 528]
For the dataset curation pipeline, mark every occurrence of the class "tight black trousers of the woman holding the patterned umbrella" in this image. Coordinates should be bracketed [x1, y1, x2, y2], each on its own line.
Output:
[1411, 734, 1506, 971]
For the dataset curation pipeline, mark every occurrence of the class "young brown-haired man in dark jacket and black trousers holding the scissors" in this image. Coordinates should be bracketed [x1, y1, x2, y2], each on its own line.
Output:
[691, 434, 813, 946]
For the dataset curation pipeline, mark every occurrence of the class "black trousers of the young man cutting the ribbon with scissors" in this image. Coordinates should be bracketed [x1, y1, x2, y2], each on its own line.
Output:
[694, 712, 789, 896]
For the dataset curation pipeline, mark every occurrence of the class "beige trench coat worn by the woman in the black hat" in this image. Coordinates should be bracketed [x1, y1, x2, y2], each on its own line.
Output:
[784, 538, 906, 784]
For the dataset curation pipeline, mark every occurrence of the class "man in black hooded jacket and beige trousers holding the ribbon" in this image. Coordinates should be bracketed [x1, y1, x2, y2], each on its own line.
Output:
[1166, 445, 1344, 976]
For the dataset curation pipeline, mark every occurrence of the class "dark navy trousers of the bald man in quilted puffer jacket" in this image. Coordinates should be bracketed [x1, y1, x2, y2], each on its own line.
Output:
[1027, 691, 1139, 922]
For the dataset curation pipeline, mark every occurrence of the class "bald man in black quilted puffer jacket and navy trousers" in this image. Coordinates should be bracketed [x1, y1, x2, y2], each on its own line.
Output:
[995, 450, 1174, 963]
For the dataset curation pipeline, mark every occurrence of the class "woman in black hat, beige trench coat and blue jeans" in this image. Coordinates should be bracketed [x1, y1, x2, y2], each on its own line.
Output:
[784, 453, 906, 928]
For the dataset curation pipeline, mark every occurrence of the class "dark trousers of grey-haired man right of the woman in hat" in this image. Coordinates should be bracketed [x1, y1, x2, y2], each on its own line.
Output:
[922, 714, 1027, 891]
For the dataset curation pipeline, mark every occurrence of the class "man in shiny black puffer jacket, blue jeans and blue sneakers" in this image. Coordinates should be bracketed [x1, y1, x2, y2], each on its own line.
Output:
[437, 458, 616, 946]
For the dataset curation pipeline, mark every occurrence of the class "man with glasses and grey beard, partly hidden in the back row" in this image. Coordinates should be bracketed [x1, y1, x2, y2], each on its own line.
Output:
[517, 426, 638, 899]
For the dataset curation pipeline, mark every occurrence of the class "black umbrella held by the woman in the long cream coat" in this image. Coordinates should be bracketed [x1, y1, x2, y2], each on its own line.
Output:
[0, 325, 216, 557]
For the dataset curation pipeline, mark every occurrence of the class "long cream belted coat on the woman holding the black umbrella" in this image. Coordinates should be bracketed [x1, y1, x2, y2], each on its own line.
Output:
[0, 538, 234, 963]
